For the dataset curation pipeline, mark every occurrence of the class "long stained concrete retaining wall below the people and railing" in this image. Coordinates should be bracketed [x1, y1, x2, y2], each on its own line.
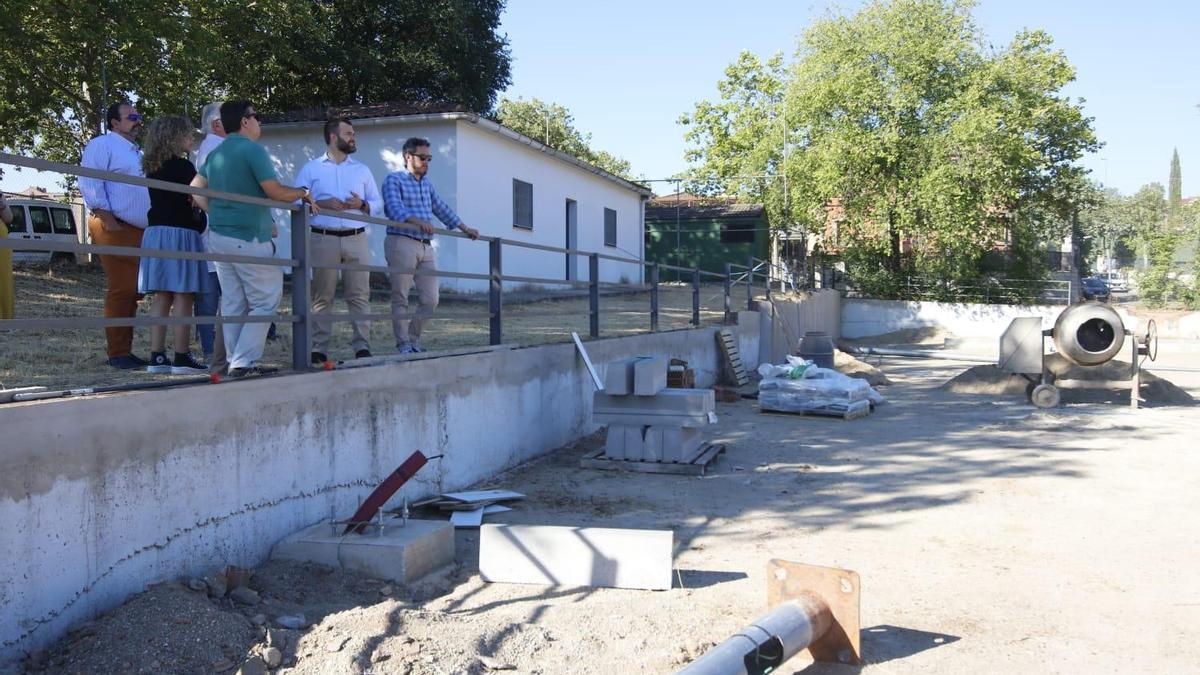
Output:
[0, 312, 758, 664]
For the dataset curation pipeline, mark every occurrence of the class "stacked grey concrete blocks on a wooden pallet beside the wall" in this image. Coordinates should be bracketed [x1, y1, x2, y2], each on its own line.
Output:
[592, 357, 716, 462]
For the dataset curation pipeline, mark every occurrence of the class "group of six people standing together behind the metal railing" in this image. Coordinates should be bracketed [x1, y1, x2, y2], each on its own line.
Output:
[79, 101, 479, 378]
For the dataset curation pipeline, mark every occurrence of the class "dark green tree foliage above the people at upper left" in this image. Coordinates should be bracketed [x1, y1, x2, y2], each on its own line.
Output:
[0, 0, 510, 162]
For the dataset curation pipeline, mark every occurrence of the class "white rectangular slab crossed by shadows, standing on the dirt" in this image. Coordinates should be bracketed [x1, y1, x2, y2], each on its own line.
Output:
[479, 525, 673, 591]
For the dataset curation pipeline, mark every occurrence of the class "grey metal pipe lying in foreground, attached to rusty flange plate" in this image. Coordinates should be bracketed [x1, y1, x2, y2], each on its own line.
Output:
[677, 593, 833, 675]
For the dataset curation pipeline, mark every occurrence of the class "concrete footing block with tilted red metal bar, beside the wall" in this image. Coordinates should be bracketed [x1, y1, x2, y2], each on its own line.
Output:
[271, 519, 454, 584]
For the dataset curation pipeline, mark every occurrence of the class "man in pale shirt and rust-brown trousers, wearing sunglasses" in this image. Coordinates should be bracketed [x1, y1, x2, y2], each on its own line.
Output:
[79, 101, 150, 370]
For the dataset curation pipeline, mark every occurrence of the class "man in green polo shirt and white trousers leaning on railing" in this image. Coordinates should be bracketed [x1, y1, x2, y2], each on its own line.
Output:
[192, 101, 317, 377]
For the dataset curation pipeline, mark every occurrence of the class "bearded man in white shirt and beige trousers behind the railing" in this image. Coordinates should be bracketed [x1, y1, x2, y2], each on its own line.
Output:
[296, 118, 383, 364]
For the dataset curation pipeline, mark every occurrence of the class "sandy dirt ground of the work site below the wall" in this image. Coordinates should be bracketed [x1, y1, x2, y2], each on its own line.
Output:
[25, 351, 1200, 675]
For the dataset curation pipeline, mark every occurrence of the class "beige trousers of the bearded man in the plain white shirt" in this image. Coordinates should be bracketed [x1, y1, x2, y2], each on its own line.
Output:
[308, 232, 371, 354]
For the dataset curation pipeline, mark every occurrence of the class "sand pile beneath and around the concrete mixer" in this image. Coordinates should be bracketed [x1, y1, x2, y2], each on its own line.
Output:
[942, 354, 1195, 406]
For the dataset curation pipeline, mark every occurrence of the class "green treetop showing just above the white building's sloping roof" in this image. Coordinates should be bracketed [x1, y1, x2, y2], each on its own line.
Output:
[496, 97, 630, 179]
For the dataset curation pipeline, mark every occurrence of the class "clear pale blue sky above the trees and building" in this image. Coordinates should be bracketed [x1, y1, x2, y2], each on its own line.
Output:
[0, 0, 1200, 196]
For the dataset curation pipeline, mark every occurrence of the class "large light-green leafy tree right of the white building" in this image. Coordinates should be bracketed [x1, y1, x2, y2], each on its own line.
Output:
[683, 0, 1099, 291]
